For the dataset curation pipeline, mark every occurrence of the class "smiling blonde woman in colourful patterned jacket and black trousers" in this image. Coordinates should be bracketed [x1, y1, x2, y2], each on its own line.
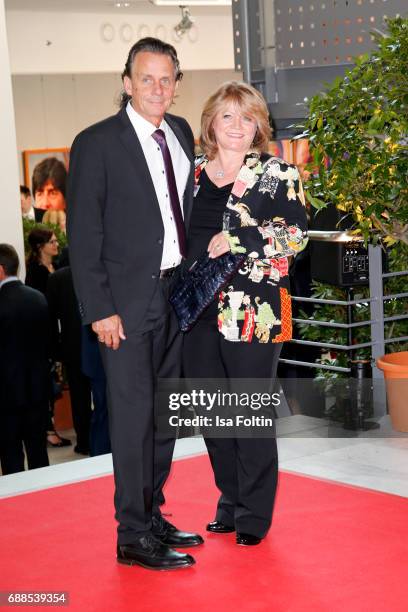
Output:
[183, 81, 307, 546]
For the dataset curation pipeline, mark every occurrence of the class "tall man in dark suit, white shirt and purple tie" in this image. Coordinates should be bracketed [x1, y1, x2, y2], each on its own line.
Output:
[68, 38, 203, 569]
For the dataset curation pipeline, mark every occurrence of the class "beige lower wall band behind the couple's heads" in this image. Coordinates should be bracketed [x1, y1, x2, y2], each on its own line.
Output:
[13, 70, 242, 182]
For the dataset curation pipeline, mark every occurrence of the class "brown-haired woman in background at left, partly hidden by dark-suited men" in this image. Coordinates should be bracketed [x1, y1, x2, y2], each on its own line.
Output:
[25, 226, 71, 448]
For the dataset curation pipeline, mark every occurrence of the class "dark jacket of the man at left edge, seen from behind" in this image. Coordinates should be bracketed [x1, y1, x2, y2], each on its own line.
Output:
[0, 281, 50, 410]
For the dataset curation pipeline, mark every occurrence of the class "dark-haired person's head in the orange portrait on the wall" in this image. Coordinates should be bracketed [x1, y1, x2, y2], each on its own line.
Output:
[31, 157, 67, 221]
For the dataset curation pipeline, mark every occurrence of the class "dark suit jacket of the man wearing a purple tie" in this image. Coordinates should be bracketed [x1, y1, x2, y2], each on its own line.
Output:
[67, 109, 194, 333]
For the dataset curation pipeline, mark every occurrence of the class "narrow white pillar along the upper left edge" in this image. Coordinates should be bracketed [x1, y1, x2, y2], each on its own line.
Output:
[0, 0, 24, 276]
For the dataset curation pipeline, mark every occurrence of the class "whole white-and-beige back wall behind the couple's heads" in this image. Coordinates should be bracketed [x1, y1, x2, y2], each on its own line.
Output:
[6, 0, 242, 191]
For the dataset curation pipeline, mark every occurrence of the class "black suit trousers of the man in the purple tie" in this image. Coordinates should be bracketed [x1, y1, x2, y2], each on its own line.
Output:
[101, 278, 181, 545]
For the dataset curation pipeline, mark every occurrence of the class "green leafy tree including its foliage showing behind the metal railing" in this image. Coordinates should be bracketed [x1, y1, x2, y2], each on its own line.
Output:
[297, 18, 408, 430]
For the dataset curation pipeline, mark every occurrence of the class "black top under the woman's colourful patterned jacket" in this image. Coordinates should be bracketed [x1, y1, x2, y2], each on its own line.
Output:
[185, 170, 233, 320]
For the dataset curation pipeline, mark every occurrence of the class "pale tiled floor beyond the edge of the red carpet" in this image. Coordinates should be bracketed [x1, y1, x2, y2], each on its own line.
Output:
[0, 416, 408, 497]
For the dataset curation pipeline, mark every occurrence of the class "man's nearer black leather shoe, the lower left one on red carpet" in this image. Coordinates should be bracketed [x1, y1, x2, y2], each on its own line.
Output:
[117, 534, 195, 570]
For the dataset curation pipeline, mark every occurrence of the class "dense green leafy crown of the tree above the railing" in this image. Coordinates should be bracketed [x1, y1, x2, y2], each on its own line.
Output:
[298, 18, 408, 246]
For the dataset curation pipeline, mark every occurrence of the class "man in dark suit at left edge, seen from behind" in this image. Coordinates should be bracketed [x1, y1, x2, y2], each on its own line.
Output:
[0, 244, 49, 474]
